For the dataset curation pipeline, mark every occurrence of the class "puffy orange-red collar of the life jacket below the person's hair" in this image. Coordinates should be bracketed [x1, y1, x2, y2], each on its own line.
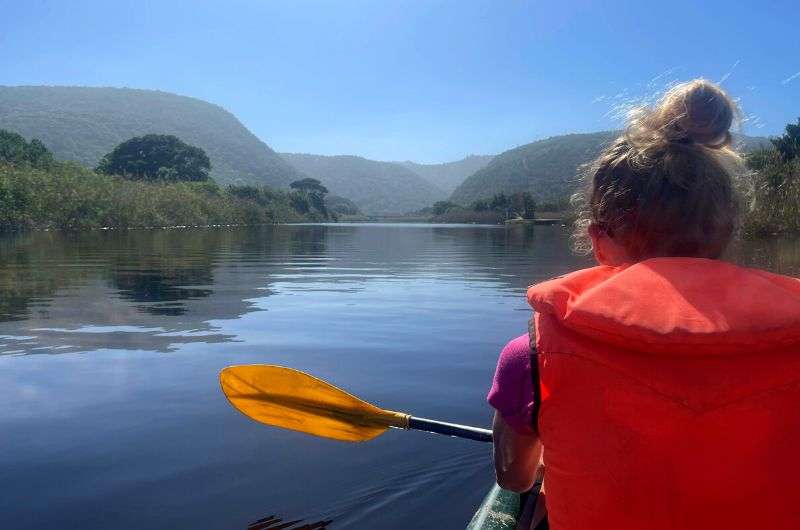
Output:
[528, 258, 800, 354]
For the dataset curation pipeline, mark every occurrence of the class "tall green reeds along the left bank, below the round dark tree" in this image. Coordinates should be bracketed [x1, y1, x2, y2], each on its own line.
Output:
[0, 162, 325, 232]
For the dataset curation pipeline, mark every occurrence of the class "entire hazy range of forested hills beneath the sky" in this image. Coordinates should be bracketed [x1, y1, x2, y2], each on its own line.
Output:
[0, 87, 768, 215]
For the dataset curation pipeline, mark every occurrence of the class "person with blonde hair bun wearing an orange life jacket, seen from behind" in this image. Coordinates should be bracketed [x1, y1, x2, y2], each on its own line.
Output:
[488, 80, 800, 530]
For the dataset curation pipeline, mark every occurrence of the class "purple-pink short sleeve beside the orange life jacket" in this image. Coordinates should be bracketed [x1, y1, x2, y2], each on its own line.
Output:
[487, 333, 535, 434]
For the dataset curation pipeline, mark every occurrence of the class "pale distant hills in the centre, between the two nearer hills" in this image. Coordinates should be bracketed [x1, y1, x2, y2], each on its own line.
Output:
[281, 153, 447, 215]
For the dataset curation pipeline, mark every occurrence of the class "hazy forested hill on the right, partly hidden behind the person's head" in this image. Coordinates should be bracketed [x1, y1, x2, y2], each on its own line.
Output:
[451, 131, 769, 204]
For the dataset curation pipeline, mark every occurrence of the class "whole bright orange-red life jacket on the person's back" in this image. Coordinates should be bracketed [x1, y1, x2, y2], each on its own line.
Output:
[528, 258, 800, 530]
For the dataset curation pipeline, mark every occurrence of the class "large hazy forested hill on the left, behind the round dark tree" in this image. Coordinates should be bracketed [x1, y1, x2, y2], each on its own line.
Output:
[0, 86, 303, 187]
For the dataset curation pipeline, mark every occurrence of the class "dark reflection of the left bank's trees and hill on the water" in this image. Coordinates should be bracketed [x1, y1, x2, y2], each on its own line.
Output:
[0, 227, 310, 353]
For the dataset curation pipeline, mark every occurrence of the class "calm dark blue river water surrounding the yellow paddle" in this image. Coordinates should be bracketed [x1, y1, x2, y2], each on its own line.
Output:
[0, 225, 800, 530]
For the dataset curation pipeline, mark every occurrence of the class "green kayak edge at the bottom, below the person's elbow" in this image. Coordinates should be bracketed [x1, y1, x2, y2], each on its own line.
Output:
[467, 480, 547, 530]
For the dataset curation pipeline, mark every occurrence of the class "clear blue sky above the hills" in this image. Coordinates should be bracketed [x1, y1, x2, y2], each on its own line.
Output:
[0, 0, 800, 162]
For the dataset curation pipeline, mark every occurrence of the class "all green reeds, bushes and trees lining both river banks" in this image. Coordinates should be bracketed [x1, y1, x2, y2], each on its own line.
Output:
[0, 119, 800, 237]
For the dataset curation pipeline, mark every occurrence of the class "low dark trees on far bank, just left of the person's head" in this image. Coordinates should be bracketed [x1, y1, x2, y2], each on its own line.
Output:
[426, 191, 536, 224]
